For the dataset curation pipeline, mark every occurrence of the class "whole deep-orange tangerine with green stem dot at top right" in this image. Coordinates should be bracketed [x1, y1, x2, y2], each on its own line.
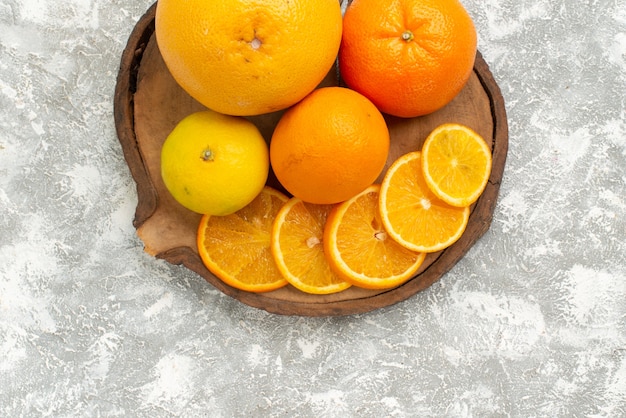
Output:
[339, 0, 477, 117]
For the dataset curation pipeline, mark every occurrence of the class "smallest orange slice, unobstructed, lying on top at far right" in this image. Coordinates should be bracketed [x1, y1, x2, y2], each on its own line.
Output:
[422, 123, 491, 207]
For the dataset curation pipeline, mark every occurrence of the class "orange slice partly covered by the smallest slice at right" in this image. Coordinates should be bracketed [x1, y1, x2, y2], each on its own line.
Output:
[379, 151, 470, 253]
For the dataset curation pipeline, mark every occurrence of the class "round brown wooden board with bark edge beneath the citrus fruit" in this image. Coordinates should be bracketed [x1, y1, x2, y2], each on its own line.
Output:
[115, 3, 508, 316]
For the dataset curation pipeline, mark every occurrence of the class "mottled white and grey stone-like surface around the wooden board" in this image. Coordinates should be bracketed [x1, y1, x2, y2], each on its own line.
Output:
[0, 0, 626, 417]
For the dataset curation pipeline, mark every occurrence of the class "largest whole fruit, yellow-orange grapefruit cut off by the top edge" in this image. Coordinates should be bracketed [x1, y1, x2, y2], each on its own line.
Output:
[155, 0, 342, 116]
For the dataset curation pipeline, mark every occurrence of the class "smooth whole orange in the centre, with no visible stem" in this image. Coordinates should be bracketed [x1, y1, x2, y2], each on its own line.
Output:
[270, 87, 389, 204]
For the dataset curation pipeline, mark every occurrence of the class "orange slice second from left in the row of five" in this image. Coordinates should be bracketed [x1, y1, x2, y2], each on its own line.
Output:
[272, 197, 351, 294]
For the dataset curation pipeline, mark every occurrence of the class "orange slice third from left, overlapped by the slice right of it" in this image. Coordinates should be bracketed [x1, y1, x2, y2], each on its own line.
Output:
[324, 184, 426, 289]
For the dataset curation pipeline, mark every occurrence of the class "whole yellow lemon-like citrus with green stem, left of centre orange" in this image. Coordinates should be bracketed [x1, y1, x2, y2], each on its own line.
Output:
[161, 110, 269, 215]
